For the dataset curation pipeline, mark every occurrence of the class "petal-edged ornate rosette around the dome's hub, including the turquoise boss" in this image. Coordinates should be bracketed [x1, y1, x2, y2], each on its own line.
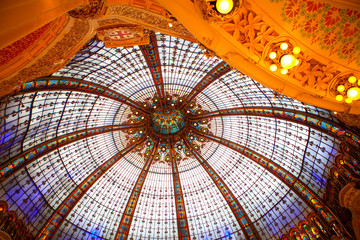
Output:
[121, 93, 211, 166]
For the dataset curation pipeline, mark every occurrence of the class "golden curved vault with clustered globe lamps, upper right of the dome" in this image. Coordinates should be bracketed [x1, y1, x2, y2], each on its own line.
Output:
[158, 0, 360, 114]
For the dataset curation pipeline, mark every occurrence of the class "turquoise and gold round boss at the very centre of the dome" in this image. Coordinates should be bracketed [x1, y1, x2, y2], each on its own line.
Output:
[150, 108, 185, 134]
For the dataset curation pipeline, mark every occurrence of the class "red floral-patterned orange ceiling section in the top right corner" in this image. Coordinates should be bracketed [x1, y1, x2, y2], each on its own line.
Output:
[270, 0, 360, 66]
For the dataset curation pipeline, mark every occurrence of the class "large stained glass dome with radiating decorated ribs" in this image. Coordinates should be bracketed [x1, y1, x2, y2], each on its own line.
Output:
[0, 34, 348, 239]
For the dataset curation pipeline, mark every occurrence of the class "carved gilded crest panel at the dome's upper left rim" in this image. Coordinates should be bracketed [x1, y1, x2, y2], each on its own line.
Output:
[97, 26, 149, 48]
